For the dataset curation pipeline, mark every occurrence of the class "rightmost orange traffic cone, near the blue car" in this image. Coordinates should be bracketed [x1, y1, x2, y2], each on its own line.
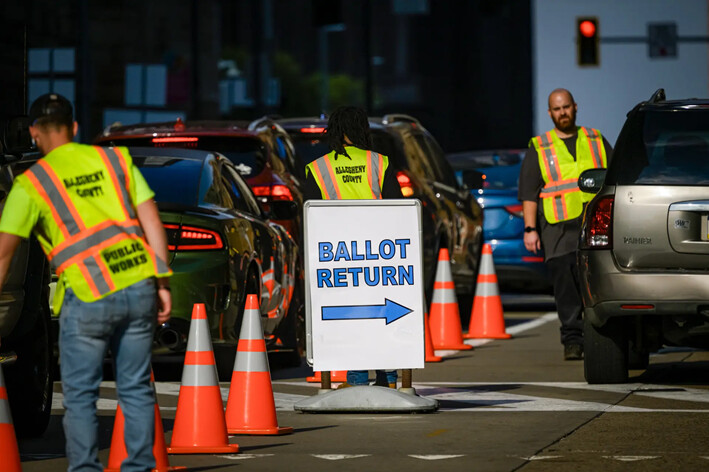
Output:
[465, 244, 512, 339]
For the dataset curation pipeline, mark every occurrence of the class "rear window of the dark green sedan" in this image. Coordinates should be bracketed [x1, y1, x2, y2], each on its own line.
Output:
[133, 156, 202, 206]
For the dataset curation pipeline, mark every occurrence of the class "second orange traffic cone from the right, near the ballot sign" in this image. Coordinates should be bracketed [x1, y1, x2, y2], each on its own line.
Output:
[429, 248, 473, 351]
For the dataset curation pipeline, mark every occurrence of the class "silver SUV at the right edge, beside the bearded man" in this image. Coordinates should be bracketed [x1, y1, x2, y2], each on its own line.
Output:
[578, 89, 709, 383]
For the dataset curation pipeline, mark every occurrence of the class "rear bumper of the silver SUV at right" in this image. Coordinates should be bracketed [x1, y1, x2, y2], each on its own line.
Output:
[579, 250, 709, 326]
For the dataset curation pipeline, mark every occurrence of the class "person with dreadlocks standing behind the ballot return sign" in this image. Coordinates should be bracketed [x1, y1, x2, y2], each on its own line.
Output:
[304, 106, 403, 388]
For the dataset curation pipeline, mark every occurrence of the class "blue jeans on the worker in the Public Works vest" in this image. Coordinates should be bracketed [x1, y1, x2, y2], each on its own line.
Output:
[59, 278, 157, 472]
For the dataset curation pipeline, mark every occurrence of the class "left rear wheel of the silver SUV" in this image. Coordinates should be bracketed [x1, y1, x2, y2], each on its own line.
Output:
[583, 318, 628, 384]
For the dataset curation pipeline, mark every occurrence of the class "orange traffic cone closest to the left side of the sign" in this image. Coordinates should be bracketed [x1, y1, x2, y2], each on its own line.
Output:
[226, 295, 293, 435]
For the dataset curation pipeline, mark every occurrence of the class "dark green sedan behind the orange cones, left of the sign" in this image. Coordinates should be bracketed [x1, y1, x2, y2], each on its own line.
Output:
[130, 148, 302, 379]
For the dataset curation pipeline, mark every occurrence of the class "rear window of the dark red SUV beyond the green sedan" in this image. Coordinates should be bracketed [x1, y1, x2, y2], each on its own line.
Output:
[102, 136, 266, 179]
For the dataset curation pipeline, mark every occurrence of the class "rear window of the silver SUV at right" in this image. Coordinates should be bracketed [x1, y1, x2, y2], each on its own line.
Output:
[607, 110, 709, 186]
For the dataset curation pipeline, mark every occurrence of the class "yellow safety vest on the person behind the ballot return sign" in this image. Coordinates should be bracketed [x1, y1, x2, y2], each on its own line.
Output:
[305, 146, 389, 200]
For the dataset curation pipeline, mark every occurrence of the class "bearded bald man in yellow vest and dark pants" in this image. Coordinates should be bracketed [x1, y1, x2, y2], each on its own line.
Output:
[518, 89, 612, 360]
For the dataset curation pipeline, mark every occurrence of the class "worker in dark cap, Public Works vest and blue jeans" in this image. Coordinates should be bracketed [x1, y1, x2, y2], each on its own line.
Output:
[0, 94, 172, 471]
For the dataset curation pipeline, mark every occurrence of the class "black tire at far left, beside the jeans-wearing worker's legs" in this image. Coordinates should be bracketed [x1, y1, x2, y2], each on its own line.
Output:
[5, 243, 54, 438]
